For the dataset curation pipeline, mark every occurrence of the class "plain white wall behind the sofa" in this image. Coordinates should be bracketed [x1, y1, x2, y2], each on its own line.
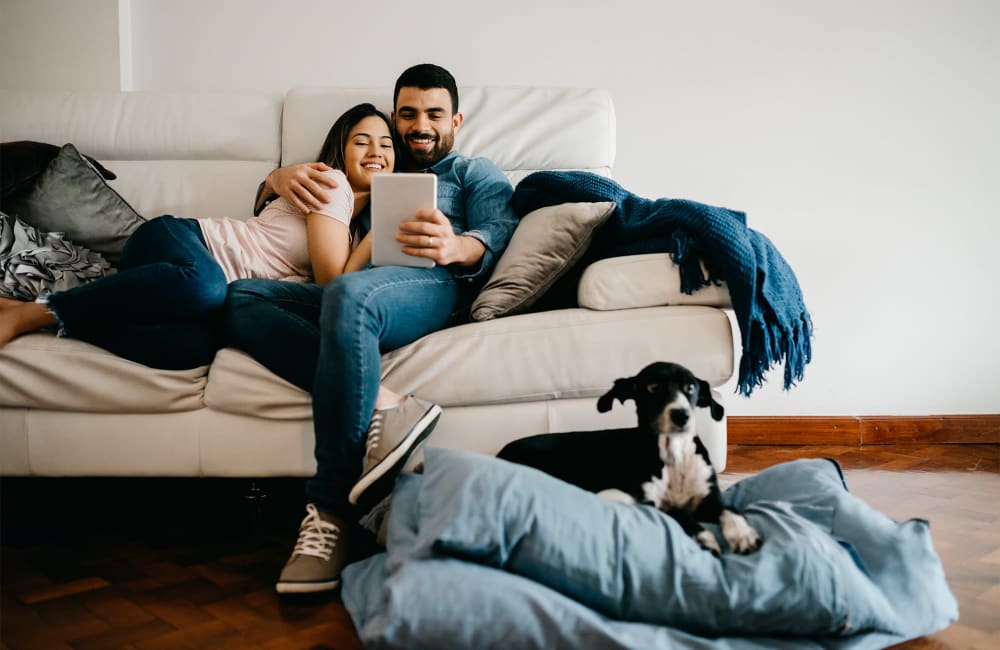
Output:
[0, 0, 1000, 415]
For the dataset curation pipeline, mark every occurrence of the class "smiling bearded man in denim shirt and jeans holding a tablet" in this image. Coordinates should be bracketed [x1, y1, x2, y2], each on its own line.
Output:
[226, 64, 517, 593]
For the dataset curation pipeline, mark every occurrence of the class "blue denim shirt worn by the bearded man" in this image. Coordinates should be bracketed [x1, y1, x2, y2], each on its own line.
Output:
[424, 151, 518, 281]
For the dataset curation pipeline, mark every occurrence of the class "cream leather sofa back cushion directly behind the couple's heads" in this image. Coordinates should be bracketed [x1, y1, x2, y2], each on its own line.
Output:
[281, 86, 615, 183]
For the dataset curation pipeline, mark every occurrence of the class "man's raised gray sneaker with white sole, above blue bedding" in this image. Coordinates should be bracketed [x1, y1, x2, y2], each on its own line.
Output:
[347, 395, 441, 505]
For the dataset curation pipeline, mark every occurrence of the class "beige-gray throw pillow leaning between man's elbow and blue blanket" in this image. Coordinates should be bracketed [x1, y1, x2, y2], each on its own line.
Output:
[472, 201, 616, 321]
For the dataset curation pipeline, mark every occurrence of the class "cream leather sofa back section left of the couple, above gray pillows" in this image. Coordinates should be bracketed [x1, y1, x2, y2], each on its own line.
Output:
[0, 90, 283, 218]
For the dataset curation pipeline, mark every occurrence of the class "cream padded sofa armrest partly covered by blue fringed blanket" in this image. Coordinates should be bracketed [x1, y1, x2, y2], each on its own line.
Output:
[577, 253, 731, 311]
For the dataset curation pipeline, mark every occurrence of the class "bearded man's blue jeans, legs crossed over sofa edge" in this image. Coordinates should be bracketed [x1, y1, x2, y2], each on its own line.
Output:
[224, 266, 477, 517]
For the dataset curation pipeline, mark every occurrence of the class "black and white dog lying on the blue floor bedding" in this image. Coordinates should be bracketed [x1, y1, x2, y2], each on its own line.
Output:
[498, 362, 762, 556]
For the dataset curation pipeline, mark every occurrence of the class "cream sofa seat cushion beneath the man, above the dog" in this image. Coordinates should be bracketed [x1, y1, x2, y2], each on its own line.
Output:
[205, 306, 734, 420]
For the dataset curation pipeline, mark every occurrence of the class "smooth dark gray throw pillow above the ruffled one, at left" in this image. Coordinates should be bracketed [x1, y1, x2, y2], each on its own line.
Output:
[5, 144, 145, 265]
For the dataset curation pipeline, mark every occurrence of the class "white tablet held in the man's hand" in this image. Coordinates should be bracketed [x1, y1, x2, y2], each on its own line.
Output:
[371, 174, 437, 268]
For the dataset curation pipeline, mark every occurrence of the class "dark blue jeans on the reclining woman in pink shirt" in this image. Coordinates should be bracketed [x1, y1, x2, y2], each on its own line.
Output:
[49, 215, 226, 370]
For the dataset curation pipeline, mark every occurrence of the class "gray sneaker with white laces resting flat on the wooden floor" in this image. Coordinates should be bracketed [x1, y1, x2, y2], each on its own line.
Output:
[275, 503, 350, 594]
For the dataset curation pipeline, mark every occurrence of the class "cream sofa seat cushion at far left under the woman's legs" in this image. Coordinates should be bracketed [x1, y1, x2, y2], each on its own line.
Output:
[0, 333, 208, 413]
